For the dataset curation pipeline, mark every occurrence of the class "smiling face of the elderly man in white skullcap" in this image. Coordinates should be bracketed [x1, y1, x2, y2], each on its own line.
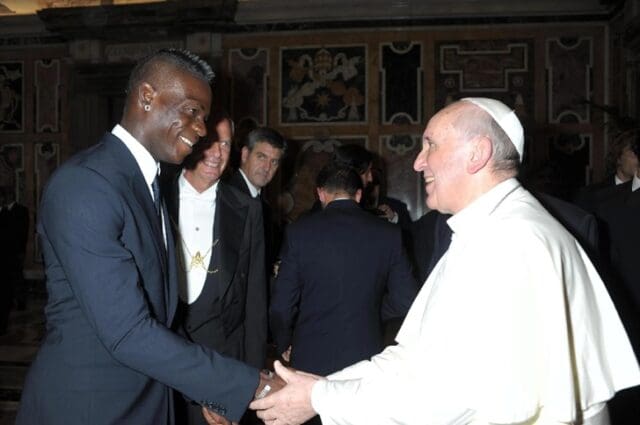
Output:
[413, 108, 468, 214]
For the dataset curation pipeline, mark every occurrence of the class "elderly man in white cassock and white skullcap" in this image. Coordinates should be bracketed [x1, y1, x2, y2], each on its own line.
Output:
[251, 98, 640, 425]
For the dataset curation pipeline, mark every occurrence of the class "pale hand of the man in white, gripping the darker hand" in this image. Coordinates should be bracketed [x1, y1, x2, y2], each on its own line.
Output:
[249, 360, 322, 425]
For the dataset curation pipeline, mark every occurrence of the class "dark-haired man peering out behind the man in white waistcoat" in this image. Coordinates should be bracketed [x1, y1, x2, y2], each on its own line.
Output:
[228, 127, 287, 276]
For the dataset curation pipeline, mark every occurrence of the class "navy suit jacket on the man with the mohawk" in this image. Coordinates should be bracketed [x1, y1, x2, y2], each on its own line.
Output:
[17, 134, 258, 425]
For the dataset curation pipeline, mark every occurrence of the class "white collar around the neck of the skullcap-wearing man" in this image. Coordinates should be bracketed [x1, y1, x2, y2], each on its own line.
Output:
[447, 178, 520, 236]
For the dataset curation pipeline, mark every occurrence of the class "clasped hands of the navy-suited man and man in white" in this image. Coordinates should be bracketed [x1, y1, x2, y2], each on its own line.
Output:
[202, 360, 323, 425]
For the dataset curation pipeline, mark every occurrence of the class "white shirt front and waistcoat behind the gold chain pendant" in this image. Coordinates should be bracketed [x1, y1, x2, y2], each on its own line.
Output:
[178, 172, 218, 304]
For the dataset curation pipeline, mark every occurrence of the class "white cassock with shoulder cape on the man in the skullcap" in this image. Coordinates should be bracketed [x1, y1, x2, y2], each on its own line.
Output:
[312, 179, 640, 425]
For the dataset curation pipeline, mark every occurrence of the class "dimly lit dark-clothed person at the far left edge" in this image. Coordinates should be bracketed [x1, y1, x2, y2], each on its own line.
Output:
[0, 187, 29, 335]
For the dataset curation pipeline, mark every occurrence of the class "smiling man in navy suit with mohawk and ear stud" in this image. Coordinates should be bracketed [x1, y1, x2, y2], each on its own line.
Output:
[16, 49, 275, 425]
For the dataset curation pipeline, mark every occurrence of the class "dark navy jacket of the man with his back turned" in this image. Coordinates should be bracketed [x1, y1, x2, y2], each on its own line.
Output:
[270, 200, 417, 375]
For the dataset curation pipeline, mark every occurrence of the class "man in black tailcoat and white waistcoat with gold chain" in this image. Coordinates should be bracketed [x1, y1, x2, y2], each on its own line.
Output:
[164, 115, 267, 424]
